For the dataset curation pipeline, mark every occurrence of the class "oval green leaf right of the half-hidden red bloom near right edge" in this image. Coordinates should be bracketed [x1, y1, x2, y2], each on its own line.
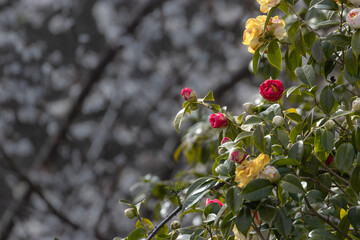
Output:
[335, 143, 355, 172]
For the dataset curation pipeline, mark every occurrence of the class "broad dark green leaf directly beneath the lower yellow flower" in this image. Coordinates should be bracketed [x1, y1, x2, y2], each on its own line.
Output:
[242, 179, 273, 201]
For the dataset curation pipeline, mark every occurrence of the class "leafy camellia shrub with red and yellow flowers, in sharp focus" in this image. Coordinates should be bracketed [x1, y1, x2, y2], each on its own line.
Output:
[118, 0, 360, 240]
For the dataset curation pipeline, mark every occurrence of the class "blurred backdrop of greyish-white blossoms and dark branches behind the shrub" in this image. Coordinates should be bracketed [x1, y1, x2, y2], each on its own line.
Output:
[0, 0, 261, 240]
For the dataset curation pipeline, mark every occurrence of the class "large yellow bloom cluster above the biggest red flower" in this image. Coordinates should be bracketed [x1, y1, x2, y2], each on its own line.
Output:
[243, 15, 286, 53]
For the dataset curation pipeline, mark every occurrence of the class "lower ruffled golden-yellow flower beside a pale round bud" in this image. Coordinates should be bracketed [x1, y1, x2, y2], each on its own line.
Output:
[235, 153, 270, 188]
